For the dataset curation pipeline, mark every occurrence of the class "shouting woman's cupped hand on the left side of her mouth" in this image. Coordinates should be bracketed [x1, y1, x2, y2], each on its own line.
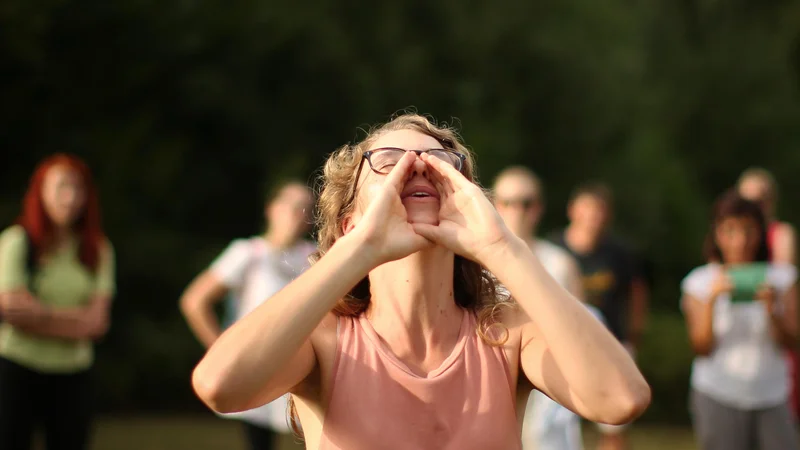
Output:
[350, 152, 433, 266]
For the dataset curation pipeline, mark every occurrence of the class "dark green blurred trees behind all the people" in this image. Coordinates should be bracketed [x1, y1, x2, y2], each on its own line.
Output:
[0, 0, 800, 421]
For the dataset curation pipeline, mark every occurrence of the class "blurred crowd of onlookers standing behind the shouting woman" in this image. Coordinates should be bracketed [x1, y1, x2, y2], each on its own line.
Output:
[0, 142, 800, 450]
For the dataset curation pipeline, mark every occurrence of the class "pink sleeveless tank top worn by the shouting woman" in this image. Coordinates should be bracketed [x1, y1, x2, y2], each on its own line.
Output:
[319, 313, 521, 450]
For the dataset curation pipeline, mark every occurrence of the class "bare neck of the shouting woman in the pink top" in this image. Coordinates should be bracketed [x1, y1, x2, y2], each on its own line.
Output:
[366, 247, 464, 372]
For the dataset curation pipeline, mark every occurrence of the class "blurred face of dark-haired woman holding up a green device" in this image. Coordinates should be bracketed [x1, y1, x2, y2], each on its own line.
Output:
[715, 217, 762, 264]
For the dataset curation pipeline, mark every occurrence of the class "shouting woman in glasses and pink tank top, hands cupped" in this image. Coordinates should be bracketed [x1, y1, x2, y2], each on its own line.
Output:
[192, 115, 650, 450]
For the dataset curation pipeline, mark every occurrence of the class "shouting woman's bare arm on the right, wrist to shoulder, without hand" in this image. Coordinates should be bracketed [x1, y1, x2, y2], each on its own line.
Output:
[486, 240, 650, 424]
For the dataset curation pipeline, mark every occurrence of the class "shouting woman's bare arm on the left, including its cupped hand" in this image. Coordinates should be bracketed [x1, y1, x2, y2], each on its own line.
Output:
[192, 152, 430, 412]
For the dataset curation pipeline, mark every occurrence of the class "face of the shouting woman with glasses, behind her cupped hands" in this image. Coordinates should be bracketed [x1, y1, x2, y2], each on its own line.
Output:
[352, 130, 443, 229]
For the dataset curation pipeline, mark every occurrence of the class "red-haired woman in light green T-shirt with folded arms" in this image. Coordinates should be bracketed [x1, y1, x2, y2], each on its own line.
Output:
[0, 154, 114, 450]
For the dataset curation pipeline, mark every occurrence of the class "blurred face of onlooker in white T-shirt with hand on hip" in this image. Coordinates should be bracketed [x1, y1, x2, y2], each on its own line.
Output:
[267, 183, 313, 239]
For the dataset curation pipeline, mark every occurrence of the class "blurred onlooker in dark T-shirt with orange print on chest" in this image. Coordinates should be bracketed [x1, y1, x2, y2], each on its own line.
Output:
[552, 183, 648, 450]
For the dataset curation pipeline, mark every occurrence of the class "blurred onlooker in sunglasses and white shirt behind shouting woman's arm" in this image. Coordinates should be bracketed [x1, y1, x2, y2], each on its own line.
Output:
[493, 166, 600, 450]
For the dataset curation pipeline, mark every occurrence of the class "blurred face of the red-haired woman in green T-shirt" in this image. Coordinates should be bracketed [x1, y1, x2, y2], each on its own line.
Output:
[42, 165, 86, 227]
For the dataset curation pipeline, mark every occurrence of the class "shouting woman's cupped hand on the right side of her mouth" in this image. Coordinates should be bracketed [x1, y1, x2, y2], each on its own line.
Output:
[414, 153, 512, 265]
